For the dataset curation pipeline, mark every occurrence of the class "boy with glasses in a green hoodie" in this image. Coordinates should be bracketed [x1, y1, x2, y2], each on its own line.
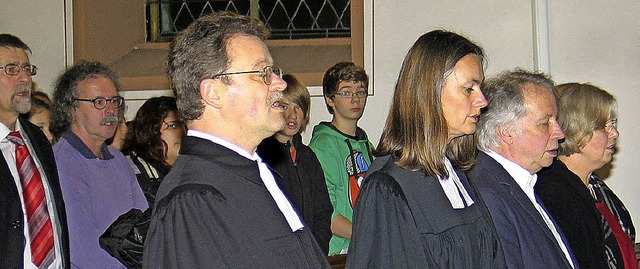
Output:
[309, 62, 373, 255]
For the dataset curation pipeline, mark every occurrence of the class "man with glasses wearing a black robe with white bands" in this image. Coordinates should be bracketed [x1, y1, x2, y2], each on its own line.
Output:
[143, 12, 328, 268]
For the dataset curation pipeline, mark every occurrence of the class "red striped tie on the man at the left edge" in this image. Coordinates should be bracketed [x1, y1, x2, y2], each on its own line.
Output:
[7, 132, 55, 268]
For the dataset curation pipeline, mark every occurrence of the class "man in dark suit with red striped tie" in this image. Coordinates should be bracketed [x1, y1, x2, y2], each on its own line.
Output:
[0, 34, 69, 268]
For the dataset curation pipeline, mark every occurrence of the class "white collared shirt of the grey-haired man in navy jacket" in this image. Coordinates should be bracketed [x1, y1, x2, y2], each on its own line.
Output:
[485, 150, 576, 268]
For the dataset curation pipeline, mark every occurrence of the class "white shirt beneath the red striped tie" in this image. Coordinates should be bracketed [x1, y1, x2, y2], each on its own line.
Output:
[0, 121, 62, 268]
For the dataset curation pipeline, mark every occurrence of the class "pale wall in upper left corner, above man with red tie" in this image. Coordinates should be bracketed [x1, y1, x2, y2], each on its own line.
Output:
[0, 0, 67, 96]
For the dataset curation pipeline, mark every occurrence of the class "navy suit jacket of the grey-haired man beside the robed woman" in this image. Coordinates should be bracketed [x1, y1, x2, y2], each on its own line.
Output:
[469, 152, 577, 269]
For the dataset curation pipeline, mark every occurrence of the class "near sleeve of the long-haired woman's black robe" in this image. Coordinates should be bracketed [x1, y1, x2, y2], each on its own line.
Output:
[347, 172, 437, 268]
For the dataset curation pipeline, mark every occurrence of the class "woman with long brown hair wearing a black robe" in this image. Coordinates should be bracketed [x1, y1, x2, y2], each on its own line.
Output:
[347, 30, 506, 268]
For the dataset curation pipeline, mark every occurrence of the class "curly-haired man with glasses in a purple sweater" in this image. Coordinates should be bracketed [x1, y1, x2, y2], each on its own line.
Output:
[51, 59, 148, 268]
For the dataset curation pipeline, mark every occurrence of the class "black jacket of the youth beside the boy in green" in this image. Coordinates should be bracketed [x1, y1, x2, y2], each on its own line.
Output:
[258, 134, 333, 254]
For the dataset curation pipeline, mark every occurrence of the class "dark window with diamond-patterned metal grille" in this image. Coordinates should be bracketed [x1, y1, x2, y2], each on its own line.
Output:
[146, 0, 351, 42]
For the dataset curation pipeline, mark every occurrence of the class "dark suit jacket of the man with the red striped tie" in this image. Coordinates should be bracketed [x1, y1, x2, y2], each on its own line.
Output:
[0, 119, 70, 268]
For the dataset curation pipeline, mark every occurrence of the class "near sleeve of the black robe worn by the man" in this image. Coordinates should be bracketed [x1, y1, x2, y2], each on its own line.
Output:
[143, 185, 259, 268]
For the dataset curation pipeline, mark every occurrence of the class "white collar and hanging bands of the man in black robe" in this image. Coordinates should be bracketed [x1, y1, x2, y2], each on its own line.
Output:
[187, 130, 304, 232]
